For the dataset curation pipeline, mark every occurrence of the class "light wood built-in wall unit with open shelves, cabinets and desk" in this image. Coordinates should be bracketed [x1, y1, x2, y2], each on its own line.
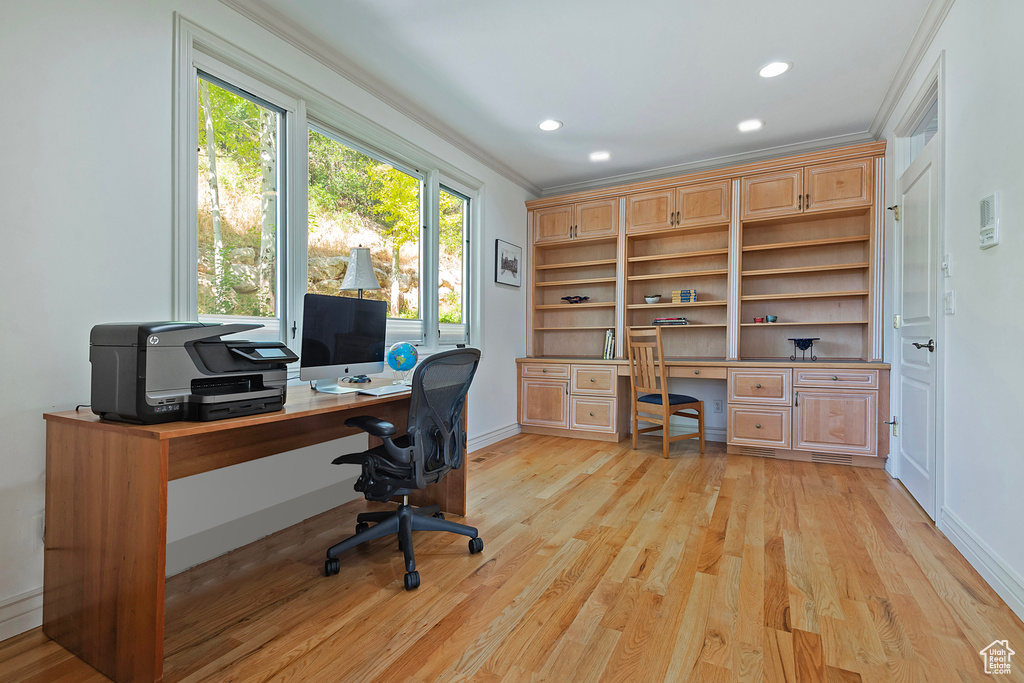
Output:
[520, 142, 888, 466]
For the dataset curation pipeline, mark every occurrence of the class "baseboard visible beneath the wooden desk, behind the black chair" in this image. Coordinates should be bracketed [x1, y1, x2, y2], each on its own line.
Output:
[166, 477, 359, 577]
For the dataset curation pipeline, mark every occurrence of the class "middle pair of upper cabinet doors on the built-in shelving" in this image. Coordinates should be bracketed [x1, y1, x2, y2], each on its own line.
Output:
[626, 180, 729, 232]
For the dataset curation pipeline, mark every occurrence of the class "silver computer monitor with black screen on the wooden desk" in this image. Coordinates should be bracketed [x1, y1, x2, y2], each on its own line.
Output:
[299, 294, 387, 393]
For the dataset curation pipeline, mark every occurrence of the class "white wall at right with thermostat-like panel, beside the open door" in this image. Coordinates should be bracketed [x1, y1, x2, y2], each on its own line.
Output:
[885, 0, 1024, 616]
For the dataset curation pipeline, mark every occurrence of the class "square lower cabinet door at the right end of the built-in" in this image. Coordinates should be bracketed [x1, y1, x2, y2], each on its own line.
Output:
[793, 389, 879, 456]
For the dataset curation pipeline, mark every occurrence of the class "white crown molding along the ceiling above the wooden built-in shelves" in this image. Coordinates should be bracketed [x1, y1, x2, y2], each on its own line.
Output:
[541, 131, 878, 199]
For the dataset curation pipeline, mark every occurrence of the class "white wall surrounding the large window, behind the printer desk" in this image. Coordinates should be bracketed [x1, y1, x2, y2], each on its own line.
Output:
[0, 0, 530, 639]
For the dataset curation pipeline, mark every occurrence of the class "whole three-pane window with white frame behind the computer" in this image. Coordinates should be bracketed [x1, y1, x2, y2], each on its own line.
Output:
[174, 16, 481, 352]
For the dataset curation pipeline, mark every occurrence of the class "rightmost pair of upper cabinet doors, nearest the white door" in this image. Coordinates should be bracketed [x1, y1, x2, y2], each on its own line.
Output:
[742, 159, 871, 220]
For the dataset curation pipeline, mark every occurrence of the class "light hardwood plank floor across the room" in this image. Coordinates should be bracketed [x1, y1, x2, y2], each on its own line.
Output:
[0, 435, 1024, 683]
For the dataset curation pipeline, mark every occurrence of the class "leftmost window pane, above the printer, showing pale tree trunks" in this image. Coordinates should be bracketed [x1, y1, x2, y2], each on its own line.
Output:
[196, 74, 284, 330]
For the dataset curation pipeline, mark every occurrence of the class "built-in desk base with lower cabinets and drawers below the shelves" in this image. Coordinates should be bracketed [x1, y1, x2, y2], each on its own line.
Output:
[516, 356, 889, 467]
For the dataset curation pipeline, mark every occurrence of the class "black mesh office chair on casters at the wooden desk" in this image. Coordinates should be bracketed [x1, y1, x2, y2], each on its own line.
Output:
[324, 348, 483, 591]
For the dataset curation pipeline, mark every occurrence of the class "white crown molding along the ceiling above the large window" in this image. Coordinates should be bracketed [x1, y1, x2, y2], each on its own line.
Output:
[220, 0, 542, 197]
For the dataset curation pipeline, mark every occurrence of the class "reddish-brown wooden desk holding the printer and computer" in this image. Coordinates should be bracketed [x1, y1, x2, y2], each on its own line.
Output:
[43, 387, 466, 682]
